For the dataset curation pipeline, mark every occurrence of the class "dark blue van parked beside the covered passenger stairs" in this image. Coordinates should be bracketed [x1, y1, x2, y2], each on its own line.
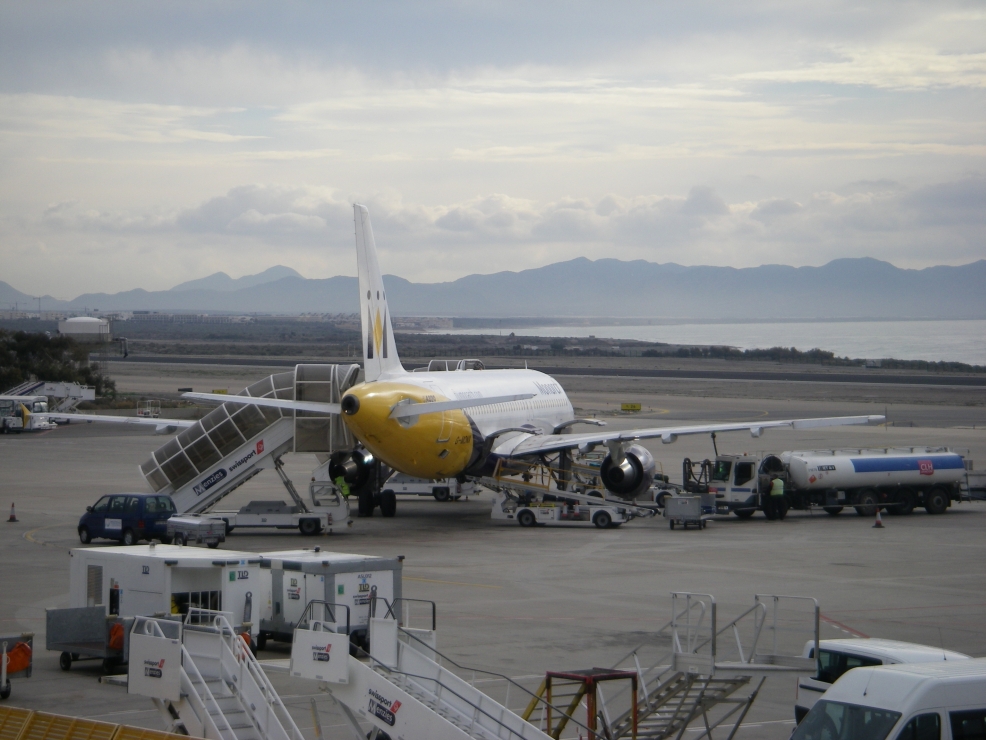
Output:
[79, 493, 175, 545]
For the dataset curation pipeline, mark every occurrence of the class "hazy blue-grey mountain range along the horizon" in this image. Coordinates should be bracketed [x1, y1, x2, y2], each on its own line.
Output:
[0, 257, 986, 320]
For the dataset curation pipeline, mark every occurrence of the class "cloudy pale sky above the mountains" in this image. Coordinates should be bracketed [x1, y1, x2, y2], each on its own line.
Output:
[0, 0, 986, 300]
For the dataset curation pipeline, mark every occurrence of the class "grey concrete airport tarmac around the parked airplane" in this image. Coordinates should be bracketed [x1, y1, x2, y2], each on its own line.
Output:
[0, 363, 986, 740]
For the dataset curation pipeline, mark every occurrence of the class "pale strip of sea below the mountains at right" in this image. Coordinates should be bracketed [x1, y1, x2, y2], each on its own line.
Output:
[432, 319, 986, 365]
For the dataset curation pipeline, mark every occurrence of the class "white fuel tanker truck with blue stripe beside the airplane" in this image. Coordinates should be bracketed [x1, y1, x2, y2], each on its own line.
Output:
[683, 447, 966, 519]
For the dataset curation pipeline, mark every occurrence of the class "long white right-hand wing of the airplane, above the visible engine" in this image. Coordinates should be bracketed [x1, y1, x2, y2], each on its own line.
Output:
[500, 416, 885, 457]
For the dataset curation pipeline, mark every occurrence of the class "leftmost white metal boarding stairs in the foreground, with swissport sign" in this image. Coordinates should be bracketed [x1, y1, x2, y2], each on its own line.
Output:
[127, 609, 304, 740]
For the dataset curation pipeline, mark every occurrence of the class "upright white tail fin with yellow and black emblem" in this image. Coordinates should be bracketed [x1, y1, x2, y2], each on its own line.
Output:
[353, 204, 404, 382]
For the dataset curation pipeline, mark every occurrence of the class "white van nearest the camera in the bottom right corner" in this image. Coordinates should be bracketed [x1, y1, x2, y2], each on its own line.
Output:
[791, 658, 986, 740]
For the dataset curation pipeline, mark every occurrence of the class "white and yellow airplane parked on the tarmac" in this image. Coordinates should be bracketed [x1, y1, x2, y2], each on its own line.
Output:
[184, 204, 884, 506]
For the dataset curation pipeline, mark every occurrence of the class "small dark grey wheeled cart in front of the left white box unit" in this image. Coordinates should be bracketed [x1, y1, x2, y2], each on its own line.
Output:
[45, 605, 133, 673]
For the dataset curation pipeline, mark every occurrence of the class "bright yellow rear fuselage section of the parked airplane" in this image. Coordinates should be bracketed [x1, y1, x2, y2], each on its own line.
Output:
[341, 382, 473, 479]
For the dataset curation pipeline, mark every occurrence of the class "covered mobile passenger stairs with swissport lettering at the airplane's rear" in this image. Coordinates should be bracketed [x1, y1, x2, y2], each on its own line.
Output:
[140, 365, 359, 534]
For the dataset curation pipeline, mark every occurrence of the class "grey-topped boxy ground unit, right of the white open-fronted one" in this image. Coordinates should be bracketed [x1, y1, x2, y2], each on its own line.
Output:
[257, 547, 404, 649]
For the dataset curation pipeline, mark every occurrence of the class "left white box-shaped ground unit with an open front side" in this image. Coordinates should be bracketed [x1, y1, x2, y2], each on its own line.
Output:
[69, 544, 261, 637]
